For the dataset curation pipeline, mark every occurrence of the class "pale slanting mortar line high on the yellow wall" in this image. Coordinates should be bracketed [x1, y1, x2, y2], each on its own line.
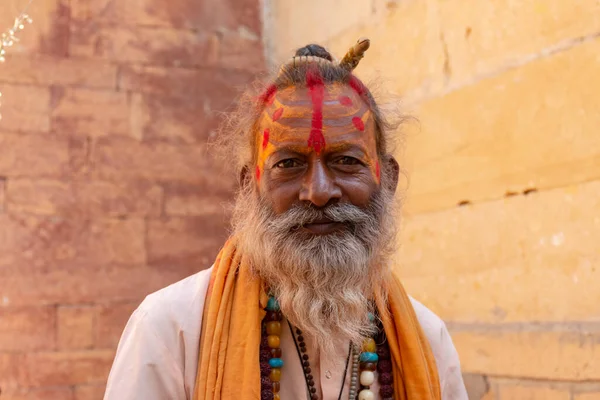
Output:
[406, 32, 600, 106]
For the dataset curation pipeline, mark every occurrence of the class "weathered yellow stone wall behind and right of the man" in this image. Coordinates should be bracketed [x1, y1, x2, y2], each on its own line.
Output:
[264, 0, 600, 400]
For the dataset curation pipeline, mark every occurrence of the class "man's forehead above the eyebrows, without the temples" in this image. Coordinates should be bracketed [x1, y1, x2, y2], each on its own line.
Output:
[255, 83, 375, 143]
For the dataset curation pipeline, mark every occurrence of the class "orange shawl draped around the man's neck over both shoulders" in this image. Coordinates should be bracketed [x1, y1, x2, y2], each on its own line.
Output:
[194, 240, 441, 400]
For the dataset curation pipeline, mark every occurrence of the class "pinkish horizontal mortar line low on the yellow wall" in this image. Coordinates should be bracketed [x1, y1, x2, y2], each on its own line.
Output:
[444, 321, 600, 335]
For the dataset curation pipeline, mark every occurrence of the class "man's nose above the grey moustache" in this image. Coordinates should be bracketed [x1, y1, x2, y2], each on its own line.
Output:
[300, 160, 342, 207]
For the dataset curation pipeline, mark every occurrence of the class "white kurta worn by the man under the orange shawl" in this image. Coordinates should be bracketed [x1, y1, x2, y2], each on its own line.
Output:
[104, 269, 468, 400]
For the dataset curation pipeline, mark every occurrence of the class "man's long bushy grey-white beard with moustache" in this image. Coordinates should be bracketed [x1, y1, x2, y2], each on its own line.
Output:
[233, 180, 395, 357]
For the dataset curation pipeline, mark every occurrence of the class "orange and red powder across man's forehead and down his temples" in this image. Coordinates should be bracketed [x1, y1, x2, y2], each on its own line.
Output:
[256, 84, 379, 181]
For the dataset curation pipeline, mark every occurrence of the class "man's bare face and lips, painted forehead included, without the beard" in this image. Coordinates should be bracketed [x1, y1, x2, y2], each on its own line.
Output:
[255, 84, 380, 234]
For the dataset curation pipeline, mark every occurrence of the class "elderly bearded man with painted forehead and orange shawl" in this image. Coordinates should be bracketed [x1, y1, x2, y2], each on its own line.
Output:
[105, 40, 467, 400]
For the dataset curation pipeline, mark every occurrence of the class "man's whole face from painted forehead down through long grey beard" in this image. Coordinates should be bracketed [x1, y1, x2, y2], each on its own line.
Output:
[232, 81, 395, 354]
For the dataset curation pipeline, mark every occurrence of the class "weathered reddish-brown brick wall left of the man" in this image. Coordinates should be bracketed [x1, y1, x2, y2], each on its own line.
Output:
[0, 0, 264, 400]
